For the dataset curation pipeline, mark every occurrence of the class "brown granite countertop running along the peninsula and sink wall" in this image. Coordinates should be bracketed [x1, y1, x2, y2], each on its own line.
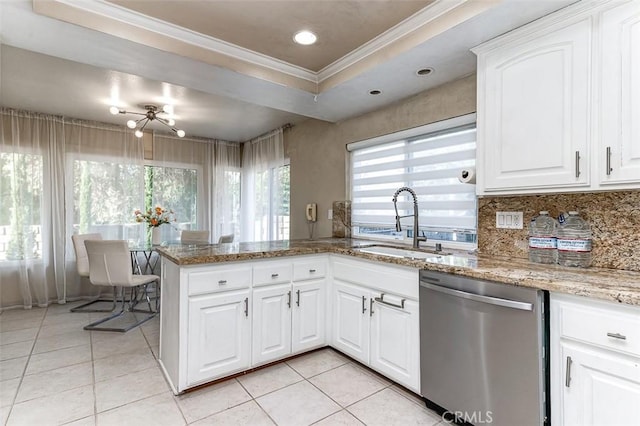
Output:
[156, 238, 640, 305]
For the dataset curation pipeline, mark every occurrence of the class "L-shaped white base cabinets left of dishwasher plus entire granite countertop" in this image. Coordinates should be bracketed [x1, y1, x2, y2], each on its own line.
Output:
[158, 239, 640, 394]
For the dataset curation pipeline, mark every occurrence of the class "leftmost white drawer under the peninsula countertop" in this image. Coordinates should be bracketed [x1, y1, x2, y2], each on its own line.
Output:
[188, 266, 251, 296]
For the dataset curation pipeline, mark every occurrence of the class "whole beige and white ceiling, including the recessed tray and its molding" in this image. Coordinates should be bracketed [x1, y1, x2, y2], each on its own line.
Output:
[0, 0, 572, 141]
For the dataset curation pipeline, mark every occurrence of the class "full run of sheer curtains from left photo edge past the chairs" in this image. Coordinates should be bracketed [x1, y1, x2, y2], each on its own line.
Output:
[0, 108, 144, 309]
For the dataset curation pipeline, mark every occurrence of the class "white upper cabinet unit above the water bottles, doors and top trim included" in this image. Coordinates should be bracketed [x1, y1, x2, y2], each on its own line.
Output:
[474, 1, 640, 195]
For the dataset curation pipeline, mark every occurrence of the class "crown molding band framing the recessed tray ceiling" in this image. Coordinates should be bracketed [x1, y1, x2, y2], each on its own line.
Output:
[33, 0, 480, 94]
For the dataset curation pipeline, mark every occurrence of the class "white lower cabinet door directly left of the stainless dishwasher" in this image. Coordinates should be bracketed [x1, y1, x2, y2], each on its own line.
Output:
[370, 294, 420, 393]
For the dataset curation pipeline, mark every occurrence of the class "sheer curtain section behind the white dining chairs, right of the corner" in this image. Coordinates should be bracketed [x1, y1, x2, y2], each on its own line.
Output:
[58, 119, 146, 300]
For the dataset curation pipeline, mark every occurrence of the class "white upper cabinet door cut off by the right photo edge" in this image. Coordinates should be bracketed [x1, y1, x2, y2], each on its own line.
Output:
[598, 1, 640, 185]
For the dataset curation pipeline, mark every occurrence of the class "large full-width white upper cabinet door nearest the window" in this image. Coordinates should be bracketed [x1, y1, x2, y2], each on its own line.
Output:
[478, 18, 592, 192]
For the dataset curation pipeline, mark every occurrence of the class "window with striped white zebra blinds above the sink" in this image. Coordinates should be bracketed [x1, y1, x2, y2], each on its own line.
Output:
[348, 114, 477, 249]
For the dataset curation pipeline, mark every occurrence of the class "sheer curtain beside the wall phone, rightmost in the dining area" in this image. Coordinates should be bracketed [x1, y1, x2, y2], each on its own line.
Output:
[241, 129, 289, 241]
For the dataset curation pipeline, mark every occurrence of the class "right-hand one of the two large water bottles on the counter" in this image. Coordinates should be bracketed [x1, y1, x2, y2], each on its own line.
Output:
[556, 212, 591, 268]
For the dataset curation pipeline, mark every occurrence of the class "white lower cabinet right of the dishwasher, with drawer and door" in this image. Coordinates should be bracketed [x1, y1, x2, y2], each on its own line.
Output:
[551, 294, 640, 426]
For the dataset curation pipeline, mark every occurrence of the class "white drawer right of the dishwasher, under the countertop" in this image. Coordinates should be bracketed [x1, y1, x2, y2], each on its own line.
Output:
[559, 304, 640, 356]
